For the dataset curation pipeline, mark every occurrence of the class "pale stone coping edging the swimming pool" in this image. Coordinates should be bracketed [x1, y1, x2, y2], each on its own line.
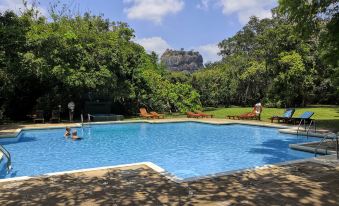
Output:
[0, 119, 333, 183]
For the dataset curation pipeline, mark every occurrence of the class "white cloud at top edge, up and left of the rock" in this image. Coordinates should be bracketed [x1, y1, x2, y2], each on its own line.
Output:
[124, 0, 184, 24]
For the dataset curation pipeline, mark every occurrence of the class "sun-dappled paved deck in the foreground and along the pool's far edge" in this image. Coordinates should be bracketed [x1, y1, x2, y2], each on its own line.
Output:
[0, 118, 339, 205]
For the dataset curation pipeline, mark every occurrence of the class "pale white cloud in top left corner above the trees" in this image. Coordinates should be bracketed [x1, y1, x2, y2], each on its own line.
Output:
[0, 0, 48, 15]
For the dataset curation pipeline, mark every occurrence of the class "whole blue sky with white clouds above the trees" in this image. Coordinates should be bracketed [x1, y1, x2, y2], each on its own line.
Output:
[0, 0, 277, 62]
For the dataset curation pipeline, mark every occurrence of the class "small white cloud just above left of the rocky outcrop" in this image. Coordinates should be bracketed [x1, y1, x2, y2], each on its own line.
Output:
[134, 37, 171, 55]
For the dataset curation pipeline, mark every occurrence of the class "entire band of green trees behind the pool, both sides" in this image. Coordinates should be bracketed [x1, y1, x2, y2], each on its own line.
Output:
[0, 0, 339, 120]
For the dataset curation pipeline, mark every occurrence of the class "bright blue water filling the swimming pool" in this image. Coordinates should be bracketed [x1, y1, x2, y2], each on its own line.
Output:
[1, 123, 317, 178]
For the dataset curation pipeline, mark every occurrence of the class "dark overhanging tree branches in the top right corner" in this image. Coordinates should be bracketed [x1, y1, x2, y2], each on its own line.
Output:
[279, 0, 339, 67]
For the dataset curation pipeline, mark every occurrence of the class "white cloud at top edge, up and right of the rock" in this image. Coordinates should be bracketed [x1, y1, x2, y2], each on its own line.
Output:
[197, 0, 277, 24]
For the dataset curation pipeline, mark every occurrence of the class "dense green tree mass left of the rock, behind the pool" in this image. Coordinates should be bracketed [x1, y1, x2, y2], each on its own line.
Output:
[0, 10, 200, 119]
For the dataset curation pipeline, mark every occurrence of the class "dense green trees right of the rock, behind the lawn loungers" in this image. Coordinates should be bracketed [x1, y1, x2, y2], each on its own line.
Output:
[192, 5, 339, 107]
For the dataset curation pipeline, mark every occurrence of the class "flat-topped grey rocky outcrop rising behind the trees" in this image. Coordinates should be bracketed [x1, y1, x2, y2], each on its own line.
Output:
[160, 49, 203, 72]
